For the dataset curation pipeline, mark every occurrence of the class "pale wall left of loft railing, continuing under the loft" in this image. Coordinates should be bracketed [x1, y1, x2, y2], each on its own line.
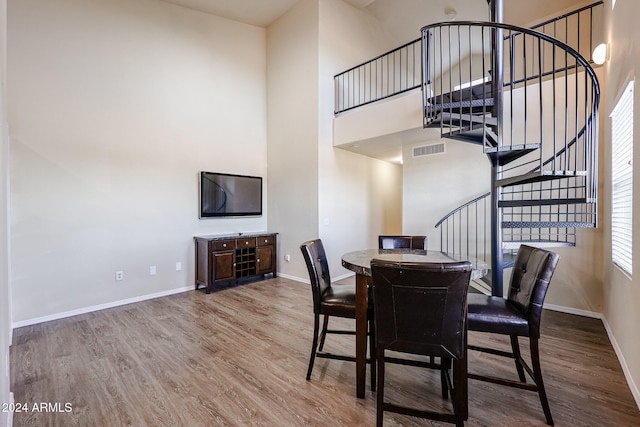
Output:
[318, 0, 402, 278]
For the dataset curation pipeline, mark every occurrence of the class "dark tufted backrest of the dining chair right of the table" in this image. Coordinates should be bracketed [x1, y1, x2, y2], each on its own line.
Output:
[508, 245, 560, 338]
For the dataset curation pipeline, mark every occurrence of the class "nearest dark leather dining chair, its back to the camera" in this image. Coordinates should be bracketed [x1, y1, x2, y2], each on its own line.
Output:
[371, 259, 471, 426]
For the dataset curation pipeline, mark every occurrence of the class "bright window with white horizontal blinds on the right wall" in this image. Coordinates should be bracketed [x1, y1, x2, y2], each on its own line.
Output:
[611, 81, 634, 274]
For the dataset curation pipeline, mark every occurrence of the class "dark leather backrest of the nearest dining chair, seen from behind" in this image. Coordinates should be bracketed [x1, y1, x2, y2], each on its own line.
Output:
[371, 259, 471, 358]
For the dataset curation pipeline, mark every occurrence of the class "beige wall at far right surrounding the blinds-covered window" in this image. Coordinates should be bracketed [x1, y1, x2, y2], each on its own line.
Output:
[601, 0, 640, 406]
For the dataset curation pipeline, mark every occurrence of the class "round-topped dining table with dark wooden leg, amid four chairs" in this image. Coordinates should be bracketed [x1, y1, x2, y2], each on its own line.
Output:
[342, 249, 489, 400]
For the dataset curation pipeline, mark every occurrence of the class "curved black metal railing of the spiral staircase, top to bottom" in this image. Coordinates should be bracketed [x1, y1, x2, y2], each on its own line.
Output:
[424, 23, 599, 259]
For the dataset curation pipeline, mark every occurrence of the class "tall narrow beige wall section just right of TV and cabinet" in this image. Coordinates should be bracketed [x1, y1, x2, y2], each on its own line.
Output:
[267, 1, 318, 279]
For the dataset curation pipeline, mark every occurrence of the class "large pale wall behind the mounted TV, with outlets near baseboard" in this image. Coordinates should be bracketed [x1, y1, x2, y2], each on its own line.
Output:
[8, 0, 267, 324]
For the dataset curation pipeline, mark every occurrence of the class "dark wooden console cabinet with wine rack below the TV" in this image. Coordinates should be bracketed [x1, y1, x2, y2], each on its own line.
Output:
[194, 233, 277, 293]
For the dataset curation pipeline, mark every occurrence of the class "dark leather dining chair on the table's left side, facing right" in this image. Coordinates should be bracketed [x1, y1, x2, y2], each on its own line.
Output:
[300, 239, 376, 391]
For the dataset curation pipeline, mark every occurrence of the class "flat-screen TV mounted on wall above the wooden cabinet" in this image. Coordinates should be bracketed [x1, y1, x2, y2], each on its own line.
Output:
[200, 171, 262, 218]
